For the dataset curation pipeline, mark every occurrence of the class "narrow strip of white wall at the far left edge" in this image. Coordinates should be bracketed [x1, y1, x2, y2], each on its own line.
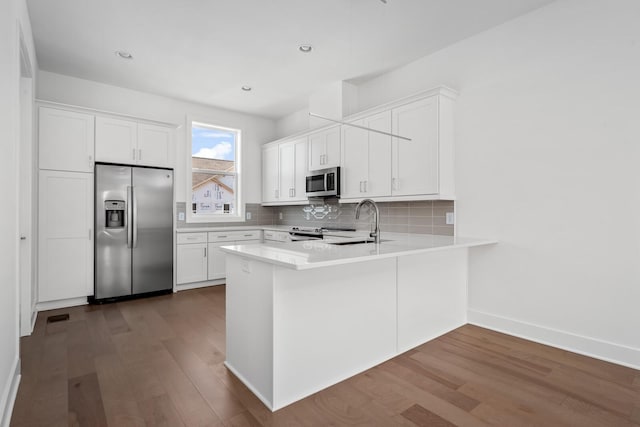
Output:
[0, 0, 36, 426]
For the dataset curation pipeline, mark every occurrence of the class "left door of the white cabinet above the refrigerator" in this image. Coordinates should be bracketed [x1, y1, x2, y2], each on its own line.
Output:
[96, 117, 138, 164]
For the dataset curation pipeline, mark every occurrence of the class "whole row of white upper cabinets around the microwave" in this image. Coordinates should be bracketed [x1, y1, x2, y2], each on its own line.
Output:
[262, 87, 457, 204]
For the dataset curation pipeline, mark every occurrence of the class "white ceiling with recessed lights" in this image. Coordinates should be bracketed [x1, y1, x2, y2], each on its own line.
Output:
[27, 0, 552, 118]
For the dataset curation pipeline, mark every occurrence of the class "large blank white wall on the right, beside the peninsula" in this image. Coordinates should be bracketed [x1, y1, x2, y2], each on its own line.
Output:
[359, 0, 640, 368]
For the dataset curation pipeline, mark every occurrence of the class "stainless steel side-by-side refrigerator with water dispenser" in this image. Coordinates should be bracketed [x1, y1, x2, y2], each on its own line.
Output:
[93, 164, 173, 302]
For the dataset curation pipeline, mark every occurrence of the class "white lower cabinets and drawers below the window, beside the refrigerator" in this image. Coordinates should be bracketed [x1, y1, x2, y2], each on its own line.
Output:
[176, 230, 262, 285]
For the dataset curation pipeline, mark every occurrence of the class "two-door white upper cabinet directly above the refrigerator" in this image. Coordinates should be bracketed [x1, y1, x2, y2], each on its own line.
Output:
[96, 117, 174, 171]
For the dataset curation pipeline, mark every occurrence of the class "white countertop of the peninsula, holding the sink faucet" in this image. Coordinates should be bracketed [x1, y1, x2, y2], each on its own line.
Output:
[221, 234, 497, 270]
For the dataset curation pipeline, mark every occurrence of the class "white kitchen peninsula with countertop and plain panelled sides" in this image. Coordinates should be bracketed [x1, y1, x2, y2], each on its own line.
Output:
[222, 233, 495, 411]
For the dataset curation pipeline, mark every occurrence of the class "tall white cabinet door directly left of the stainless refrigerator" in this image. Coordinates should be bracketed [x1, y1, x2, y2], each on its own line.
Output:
[38, 170, 93, 302]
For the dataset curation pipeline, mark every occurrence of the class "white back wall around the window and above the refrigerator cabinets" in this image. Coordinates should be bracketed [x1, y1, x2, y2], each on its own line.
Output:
[36, 71, 275, 203]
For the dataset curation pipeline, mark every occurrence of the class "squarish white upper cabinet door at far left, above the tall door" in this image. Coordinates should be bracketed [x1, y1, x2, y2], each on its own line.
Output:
[38, 107, 94, 172]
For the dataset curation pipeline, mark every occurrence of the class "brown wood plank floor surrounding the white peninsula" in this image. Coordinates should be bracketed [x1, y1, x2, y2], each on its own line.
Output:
[11, 286, 640, 427]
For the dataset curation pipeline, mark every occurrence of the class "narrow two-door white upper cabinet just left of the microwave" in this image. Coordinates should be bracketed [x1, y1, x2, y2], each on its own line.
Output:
[278, 138, 308, 202]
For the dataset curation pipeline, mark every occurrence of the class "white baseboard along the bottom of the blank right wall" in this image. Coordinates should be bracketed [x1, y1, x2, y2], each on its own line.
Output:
[468, 309, 640, 369]
